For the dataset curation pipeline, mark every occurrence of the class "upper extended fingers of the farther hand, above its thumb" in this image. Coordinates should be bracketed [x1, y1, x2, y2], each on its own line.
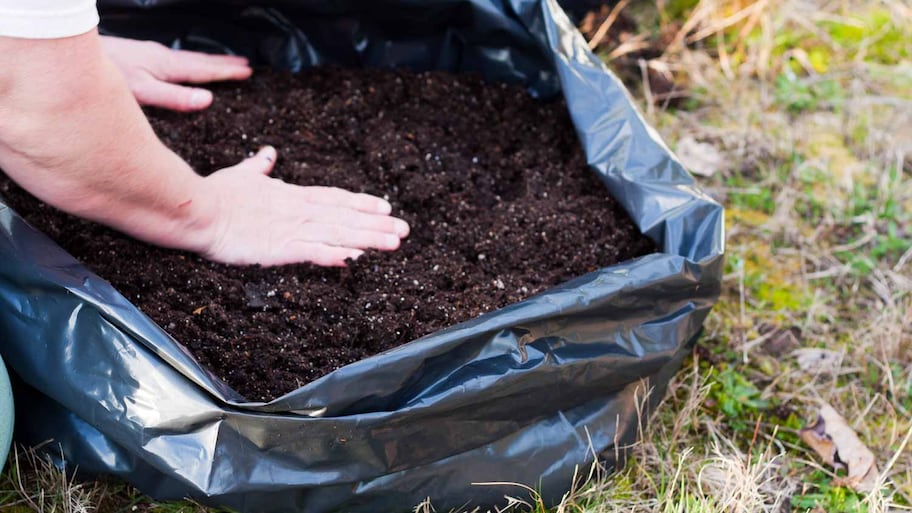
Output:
[159, 50, 253, 84]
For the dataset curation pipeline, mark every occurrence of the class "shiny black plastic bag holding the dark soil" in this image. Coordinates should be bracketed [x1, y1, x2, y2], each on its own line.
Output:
[0, 0, 723, 513]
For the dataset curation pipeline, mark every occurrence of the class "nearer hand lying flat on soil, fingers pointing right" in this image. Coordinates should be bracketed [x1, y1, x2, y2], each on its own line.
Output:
[194, 147, 409, 266]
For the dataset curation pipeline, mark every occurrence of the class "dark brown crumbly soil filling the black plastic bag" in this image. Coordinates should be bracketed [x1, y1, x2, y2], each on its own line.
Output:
[0, 68, 655, 400]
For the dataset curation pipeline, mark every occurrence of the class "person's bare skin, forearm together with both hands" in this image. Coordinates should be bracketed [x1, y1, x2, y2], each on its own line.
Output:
[0, 31, 409, 266]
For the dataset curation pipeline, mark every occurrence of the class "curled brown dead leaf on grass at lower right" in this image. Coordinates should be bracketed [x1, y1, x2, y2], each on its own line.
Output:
[799, 404, 880, 492]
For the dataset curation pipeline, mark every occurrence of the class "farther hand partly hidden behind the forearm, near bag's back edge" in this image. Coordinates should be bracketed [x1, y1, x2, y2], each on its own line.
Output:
[101, 36, 253, 112]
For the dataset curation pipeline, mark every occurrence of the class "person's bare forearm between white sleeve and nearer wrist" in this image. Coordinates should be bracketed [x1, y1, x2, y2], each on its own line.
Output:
[0, 33, 205, 250]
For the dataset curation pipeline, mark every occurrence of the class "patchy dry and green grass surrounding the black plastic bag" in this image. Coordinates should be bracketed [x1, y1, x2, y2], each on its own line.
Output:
[0, 0, 912, 513]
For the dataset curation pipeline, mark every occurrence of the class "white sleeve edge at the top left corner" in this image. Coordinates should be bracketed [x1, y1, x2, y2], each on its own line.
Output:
[0, 0, 98, 39]
